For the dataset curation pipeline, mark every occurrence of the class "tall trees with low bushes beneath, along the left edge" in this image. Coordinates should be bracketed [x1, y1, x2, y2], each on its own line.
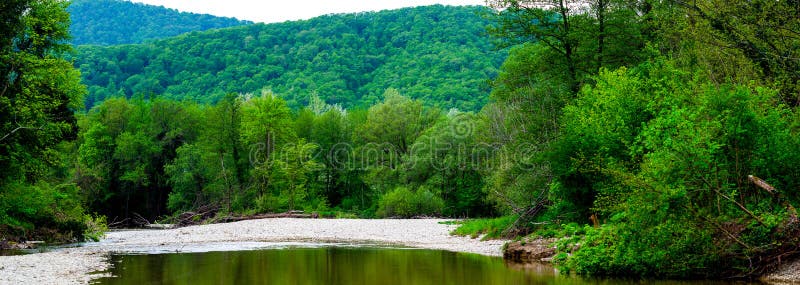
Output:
[0, 0, 95, 241]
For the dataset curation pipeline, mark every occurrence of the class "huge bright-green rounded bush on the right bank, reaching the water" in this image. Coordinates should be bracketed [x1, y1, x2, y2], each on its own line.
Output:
[553, 61, 800, 278]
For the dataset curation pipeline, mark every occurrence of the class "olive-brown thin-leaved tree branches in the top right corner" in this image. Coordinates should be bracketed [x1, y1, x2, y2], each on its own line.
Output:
[669, 0, 800, 106]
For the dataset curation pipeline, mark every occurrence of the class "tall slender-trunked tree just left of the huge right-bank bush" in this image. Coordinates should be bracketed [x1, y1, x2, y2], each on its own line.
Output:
[482, 0, 651, 224]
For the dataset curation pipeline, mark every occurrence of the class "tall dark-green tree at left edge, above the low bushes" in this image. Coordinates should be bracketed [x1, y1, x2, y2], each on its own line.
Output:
[0, 0, 86, 182]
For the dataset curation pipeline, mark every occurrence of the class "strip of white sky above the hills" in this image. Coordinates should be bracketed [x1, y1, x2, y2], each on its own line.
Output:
[129, 0, 486, 23]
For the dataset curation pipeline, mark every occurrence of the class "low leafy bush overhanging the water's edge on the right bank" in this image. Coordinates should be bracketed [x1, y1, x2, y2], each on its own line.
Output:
[557, 206, 720, 278]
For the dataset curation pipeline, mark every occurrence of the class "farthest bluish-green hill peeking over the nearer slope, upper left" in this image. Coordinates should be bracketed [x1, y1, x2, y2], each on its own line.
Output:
[67, 0, 251, 45]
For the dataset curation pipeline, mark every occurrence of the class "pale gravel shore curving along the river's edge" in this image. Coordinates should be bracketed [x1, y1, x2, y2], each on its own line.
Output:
[0, 219, 505, 284]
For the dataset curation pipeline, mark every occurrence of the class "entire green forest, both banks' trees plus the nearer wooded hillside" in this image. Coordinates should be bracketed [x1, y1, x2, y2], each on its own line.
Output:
[0, 0, 800, 278]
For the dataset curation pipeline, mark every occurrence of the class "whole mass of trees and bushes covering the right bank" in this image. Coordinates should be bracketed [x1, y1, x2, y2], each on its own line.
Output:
[483, 0, 800, 278]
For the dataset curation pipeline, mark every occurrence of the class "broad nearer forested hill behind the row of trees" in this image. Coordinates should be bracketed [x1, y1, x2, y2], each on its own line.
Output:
[76, 6, 506, 110]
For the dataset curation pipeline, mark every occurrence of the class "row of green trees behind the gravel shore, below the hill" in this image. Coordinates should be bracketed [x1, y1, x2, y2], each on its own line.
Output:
[75, 90, 500, 221]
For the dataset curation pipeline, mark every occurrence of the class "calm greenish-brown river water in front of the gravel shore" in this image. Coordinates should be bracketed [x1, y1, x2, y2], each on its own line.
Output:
[95, 246, 752, 285]
